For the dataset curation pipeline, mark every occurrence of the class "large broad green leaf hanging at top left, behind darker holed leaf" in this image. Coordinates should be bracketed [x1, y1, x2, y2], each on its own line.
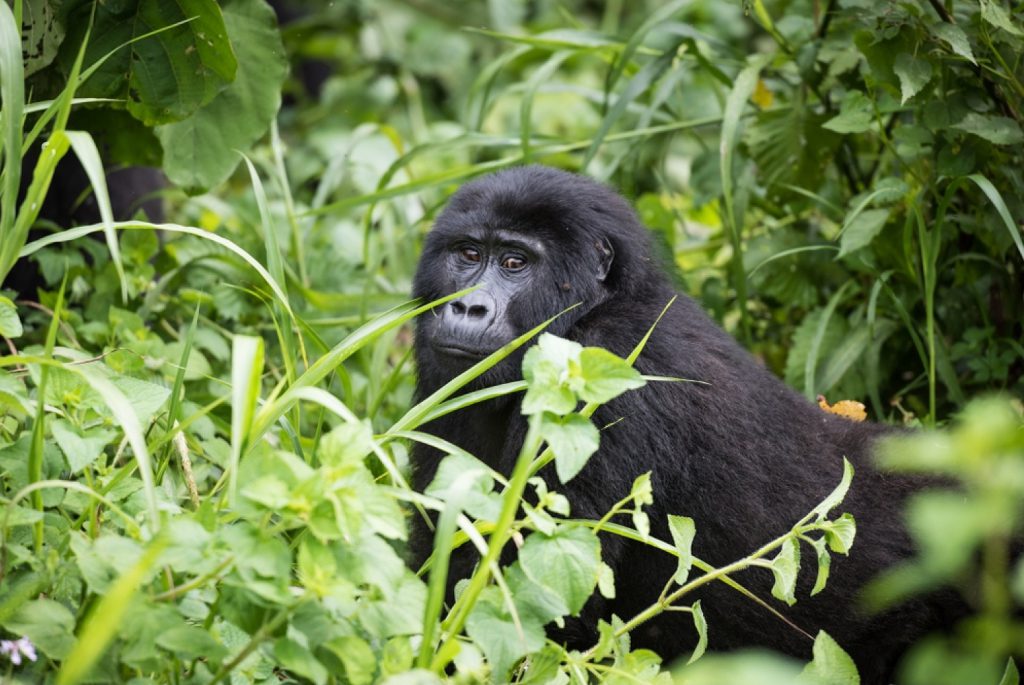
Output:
[157, 0, 288, 188]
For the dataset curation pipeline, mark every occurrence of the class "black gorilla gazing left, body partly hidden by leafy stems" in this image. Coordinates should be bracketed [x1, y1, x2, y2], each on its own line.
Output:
[412, 166, 956, 683]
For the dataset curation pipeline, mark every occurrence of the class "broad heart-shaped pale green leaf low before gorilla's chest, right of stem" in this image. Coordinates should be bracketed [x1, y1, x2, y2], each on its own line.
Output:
[519, 526, 601, 615]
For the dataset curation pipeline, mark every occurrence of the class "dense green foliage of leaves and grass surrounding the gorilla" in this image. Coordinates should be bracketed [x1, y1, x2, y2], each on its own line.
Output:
[0, 0, 1024, 685]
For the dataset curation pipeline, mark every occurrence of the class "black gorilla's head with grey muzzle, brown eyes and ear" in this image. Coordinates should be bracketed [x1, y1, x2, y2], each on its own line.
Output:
[414, 168, 614, 384]
